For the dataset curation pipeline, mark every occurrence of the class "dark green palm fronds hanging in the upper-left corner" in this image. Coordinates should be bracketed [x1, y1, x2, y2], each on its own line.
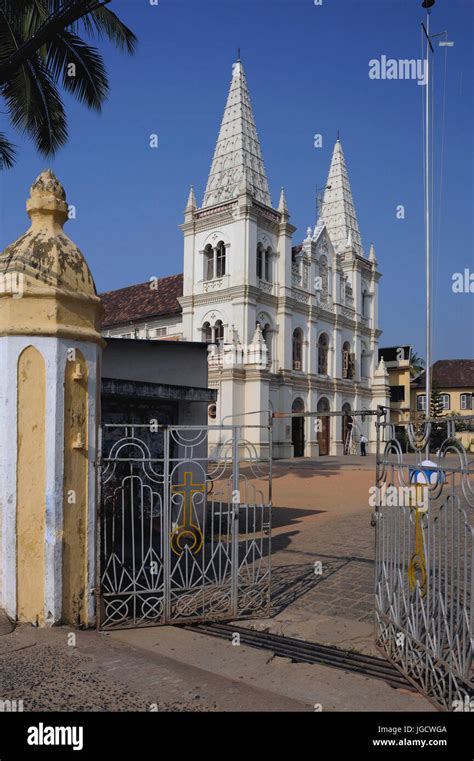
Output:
[0, 0, 137, 169]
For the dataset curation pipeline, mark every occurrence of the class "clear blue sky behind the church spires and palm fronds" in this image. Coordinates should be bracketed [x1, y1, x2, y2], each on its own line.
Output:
[0, 0, 474, 359]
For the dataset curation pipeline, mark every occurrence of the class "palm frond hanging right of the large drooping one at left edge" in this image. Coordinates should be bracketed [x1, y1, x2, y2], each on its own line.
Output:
[46, 31, 109, 111]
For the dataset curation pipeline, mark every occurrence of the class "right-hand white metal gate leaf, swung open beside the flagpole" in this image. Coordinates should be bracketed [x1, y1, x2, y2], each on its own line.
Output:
[374, 417, 474, 711]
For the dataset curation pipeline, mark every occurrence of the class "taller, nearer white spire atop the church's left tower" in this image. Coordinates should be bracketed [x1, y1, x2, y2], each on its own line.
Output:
[203, 60, 271, 206]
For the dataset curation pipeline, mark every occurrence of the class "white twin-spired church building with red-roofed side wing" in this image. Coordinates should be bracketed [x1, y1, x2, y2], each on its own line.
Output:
[101, 61, 390, 457]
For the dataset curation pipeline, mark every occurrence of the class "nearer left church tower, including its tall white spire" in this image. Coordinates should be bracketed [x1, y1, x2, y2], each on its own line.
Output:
[181, 60, 295, 446]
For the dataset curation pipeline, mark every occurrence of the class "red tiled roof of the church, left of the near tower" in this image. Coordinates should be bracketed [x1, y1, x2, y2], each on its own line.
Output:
[100, 274, 183, 328]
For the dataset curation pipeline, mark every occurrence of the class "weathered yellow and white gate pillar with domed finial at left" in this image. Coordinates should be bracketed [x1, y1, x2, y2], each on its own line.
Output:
[0, 171, 103, 626]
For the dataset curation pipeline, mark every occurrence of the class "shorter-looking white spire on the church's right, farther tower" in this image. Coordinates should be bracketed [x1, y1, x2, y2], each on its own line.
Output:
[321, 138, 364, 256]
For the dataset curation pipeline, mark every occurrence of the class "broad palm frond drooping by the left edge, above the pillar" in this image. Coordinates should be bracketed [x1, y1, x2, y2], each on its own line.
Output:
[1, 57, 68, 156]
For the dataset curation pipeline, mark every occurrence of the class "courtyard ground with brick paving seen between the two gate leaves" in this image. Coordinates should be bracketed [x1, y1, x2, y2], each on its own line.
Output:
[272, 458, 474, 623]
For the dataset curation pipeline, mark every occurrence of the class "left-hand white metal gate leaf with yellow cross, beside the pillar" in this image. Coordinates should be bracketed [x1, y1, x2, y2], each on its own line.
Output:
[97, 425, 272, 629]
